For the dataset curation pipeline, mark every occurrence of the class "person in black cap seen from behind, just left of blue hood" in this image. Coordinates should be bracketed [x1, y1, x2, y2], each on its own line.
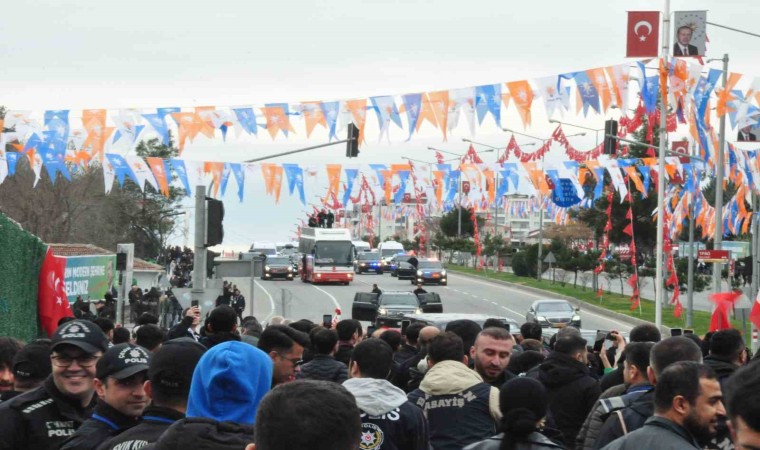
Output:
[98, 337, 206, 450]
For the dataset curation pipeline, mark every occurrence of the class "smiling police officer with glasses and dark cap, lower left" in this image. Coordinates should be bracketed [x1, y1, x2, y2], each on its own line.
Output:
[0, 320, 108, 450]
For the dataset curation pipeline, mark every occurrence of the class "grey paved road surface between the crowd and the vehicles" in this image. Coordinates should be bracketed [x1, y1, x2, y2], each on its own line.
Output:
[230, 273, 631, 331]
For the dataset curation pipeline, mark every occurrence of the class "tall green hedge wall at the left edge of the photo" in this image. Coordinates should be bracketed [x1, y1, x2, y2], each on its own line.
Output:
[0, 213, 47, 341]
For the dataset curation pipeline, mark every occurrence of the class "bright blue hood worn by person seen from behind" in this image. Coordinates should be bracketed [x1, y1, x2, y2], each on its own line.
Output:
[187, 341, 272, 425]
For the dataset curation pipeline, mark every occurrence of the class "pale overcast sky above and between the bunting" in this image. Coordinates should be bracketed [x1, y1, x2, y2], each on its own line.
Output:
[0, 0, 760, 248]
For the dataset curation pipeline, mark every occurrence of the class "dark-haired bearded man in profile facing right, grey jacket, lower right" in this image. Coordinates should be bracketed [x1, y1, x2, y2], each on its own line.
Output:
[604, 361, 726, 450]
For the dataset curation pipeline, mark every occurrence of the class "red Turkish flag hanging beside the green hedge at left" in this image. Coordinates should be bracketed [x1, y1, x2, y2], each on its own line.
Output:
[37, 248, 74, 336]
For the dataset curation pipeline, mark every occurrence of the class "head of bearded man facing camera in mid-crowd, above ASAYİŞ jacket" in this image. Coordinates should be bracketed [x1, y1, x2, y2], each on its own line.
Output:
[470, 327, 515, 388]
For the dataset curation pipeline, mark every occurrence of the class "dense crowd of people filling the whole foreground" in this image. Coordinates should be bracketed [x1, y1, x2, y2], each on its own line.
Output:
[0, 306, 760, 450]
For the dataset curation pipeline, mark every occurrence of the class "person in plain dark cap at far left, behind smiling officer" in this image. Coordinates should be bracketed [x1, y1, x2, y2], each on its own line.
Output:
[0, 339, 53, 401]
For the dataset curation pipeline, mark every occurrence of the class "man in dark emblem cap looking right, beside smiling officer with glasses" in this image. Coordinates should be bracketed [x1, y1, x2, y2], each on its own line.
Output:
[61, 344, 150, 450]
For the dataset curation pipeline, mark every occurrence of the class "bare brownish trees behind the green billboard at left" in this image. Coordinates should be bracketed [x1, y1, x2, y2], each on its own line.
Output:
[0, 133, 184, 259]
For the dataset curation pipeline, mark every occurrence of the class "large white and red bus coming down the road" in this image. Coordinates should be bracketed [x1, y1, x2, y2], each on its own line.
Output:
[298, 228, 356, 284]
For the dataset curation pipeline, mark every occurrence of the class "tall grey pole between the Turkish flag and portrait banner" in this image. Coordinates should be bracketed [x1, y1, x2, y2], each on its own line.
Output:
[655, 0, 670, 329]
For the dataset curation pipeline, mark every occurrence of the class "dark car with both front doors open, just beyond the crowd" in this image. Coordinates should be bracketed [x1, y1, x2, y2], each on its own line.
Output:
[351, 291, 443, 322]
